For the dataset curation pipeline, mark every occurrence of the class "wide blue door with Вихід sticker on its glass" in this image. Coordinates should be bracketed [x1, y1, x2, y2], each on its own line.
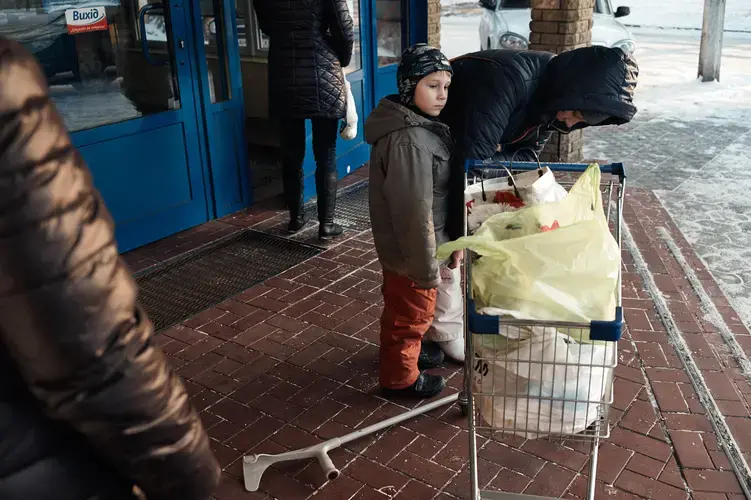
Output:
[6, 0, 210, 251]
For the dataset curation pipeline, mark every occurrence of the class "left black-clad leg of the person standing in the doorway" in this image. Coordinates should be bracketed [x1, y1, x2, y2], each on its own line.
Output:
[280, 118, 306, 233]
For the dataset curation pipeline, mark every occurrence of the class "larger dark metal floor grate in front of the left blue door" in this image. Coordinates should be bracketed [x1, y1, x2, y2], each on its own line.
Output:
[136, 229, 322, 331]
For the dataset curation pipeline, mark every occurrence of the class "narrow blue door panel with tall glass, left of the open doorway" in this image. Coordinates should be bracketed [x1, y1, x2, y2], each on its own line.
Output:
[193, 0, 251, 217]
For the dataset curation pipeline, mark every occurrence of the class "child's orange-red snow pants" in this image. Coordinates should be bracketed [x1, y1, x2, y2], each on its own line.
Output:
[380, 271, 437, 389]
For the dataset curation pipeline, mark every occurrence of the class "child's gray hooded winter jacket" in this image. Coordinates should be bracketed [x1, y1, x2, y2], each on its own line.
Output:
[365, 97, 452, 288]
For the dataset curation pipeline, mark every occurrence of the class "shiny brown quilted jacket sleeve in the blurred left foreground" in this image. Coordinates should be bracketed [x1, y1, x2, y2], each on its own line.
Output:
[0, 40, 220, 500]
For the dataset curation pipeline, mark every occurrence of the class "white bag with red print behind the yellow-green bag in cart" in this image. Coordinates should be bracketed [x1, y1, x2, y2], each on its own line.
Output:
[464, 167, 567, 233]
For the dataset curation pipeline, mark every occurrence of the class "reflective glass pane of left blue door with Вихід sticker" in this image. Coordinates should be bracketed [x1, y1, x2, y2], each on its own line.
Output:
[0, 0, 180, 131]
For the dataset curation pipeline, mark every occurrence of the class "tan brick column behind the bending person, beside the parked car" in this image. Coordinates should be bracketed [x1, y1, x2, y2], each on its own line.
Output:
[529, 0, 594, 162]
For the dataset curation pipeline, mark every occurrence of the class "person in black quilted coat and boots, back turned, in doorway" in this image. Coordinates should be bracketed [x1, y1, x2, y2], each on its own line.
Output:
[253, 0, 355, 239]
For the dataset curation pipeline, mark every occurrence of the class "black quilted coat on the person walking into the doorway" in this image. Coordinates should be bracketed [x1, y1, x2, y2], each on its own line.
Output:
[253, 0, 355, 119]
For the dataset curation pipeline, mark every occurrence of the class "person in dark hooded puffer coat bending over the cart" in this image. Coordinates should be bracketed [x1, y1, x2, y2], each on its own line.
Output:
[441, 47, 639, 239]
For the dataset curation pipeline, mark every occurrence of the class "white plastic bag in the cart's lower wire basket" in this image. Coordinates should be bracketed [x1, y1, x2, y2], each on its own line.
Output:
[473, 328, 615, 439]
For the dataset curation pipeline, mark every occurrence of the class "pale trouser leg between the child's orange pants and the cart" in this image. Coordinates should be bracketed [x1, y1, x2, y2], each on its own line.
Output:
[426, 266, 465, 363]
